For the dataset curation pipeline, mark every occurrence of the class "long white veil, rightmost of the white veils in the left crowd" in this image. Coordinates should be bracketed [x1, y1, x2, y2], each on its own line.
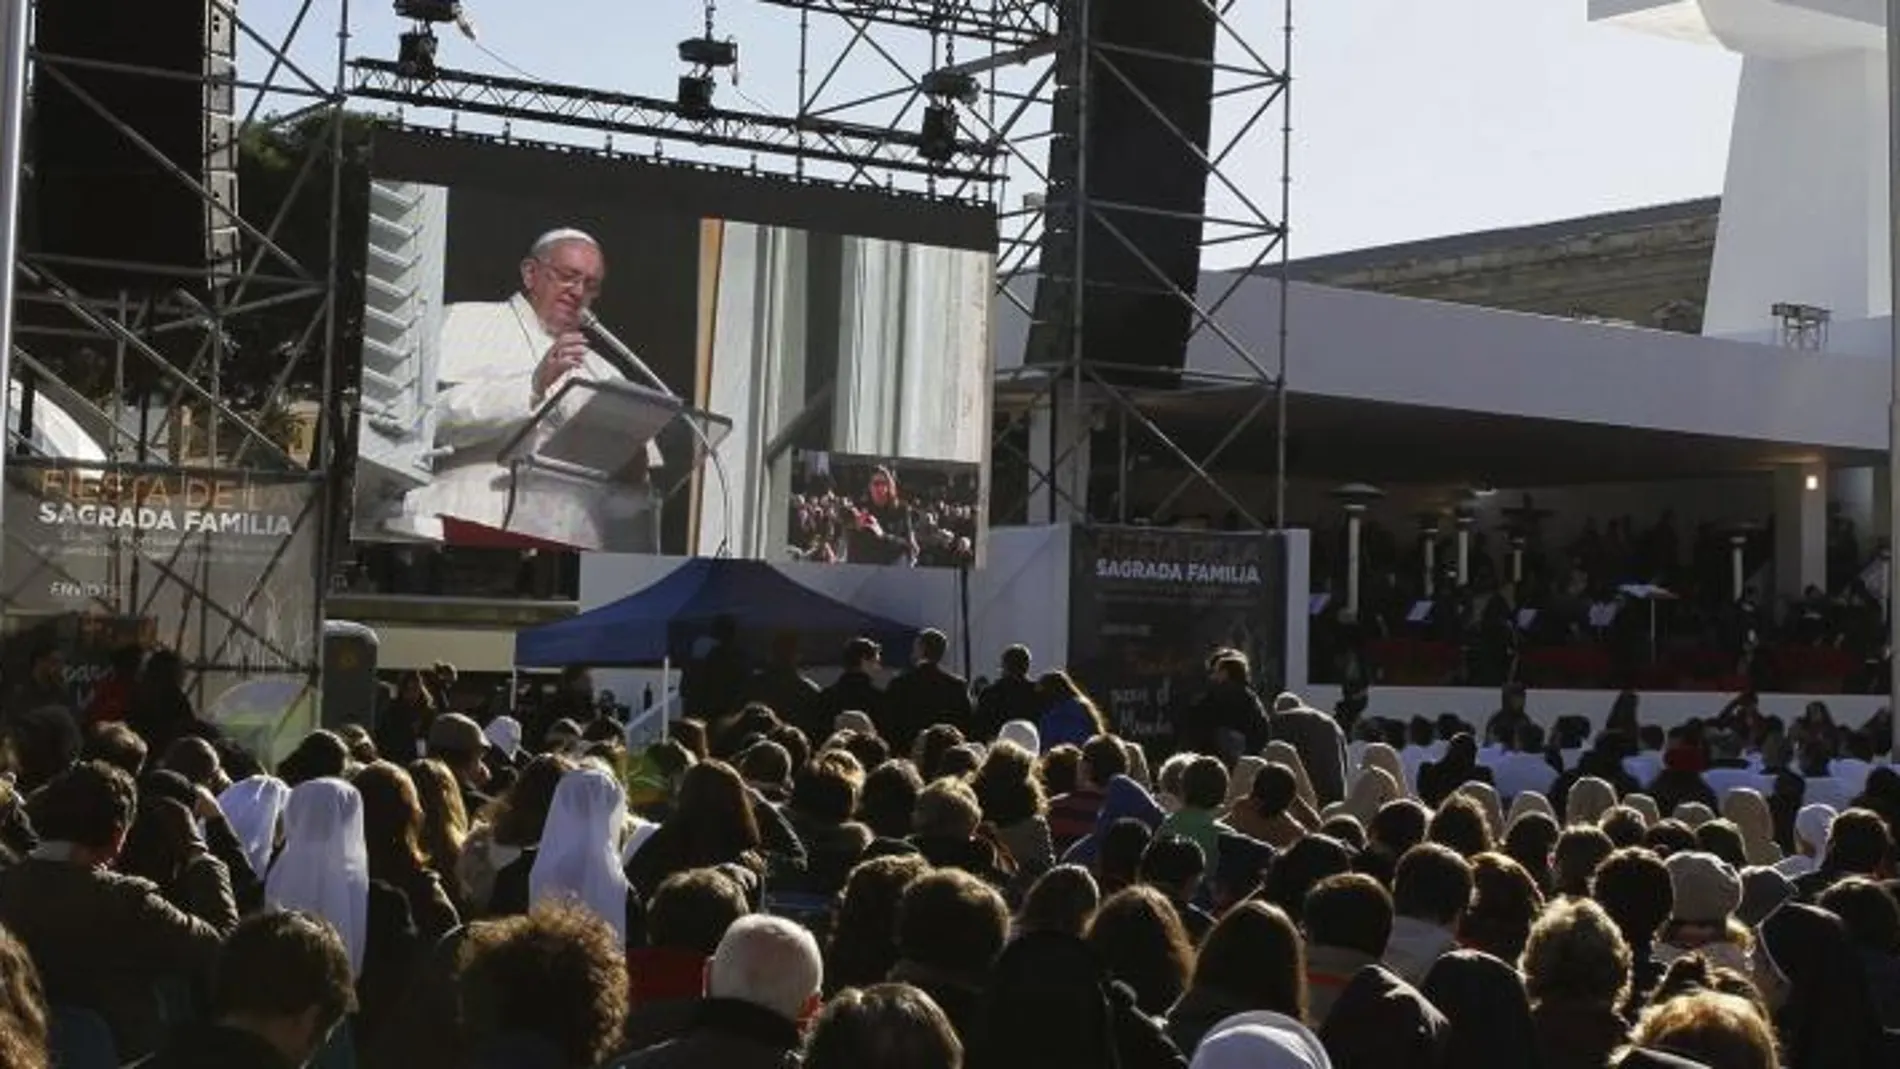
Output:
[528, 767, 627, 944]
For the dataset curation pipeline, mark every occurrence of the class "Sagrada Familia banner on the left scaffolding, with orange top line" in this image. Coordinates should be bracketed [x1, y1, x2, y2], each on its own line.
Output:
[0, 458, 323, 720]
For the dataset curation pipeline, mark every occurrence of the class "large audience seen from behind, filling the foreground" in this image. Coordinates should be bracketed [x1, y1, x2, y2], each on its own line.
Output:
[0, 630, 1900, 1069]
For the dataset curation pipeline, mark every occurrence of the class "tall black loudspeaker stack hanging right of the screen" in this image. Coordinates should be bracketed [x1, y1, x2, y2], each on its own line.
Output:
[1028, 0, 1216, 385]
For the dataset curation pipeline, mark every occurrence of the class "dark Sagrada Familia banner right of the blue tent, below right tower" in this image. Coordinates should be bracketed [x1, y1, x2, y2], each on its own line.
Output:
[1068, 526, 1286, 750]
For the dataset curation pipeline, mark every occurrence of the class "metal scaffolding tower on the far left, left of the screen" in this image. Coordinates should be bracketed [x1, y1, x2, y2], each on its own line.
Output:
[0, 0, 355, 729]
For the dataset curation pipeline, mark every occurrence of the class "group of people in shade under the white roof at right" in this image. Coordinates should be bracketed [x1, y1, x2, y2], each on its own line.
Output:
[1309, 499, 1891, 693]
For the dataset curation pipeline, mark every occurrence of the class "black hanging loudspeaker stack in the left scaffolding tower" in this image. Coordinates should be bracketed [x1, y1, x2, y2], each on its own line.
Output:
[32, 0, 238, 292]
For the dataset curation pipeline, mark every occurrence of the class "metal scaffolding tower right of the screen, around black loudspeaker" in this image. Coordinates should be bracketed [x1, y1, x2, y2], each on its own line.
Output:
[992, 0, 1292, 530]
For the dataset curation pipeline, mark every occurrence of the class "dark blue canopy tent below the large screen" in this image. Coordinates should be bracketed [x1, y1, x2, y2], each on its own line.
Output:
[515, 556, 918, 668]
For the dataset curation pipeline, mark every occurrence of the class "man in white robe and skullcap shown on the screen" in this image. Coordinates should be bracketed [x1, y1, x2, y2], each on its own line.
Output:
[405, 228, 659, 553]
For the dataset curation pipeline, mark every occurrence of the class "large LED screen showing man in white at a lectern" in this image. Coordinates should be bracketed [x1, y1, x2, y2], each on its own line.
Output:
[353, 133, 996, 566]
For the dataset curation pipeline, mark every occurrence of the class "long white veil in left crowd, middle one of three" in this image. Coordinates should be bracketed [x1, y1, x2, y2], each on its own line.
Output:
[264, 777, 369, 974]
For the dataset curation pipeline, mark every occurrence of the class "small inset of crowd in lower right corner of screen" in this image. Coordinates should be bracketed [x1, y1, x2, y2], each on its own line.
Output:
[787, 452, 982, 568]
